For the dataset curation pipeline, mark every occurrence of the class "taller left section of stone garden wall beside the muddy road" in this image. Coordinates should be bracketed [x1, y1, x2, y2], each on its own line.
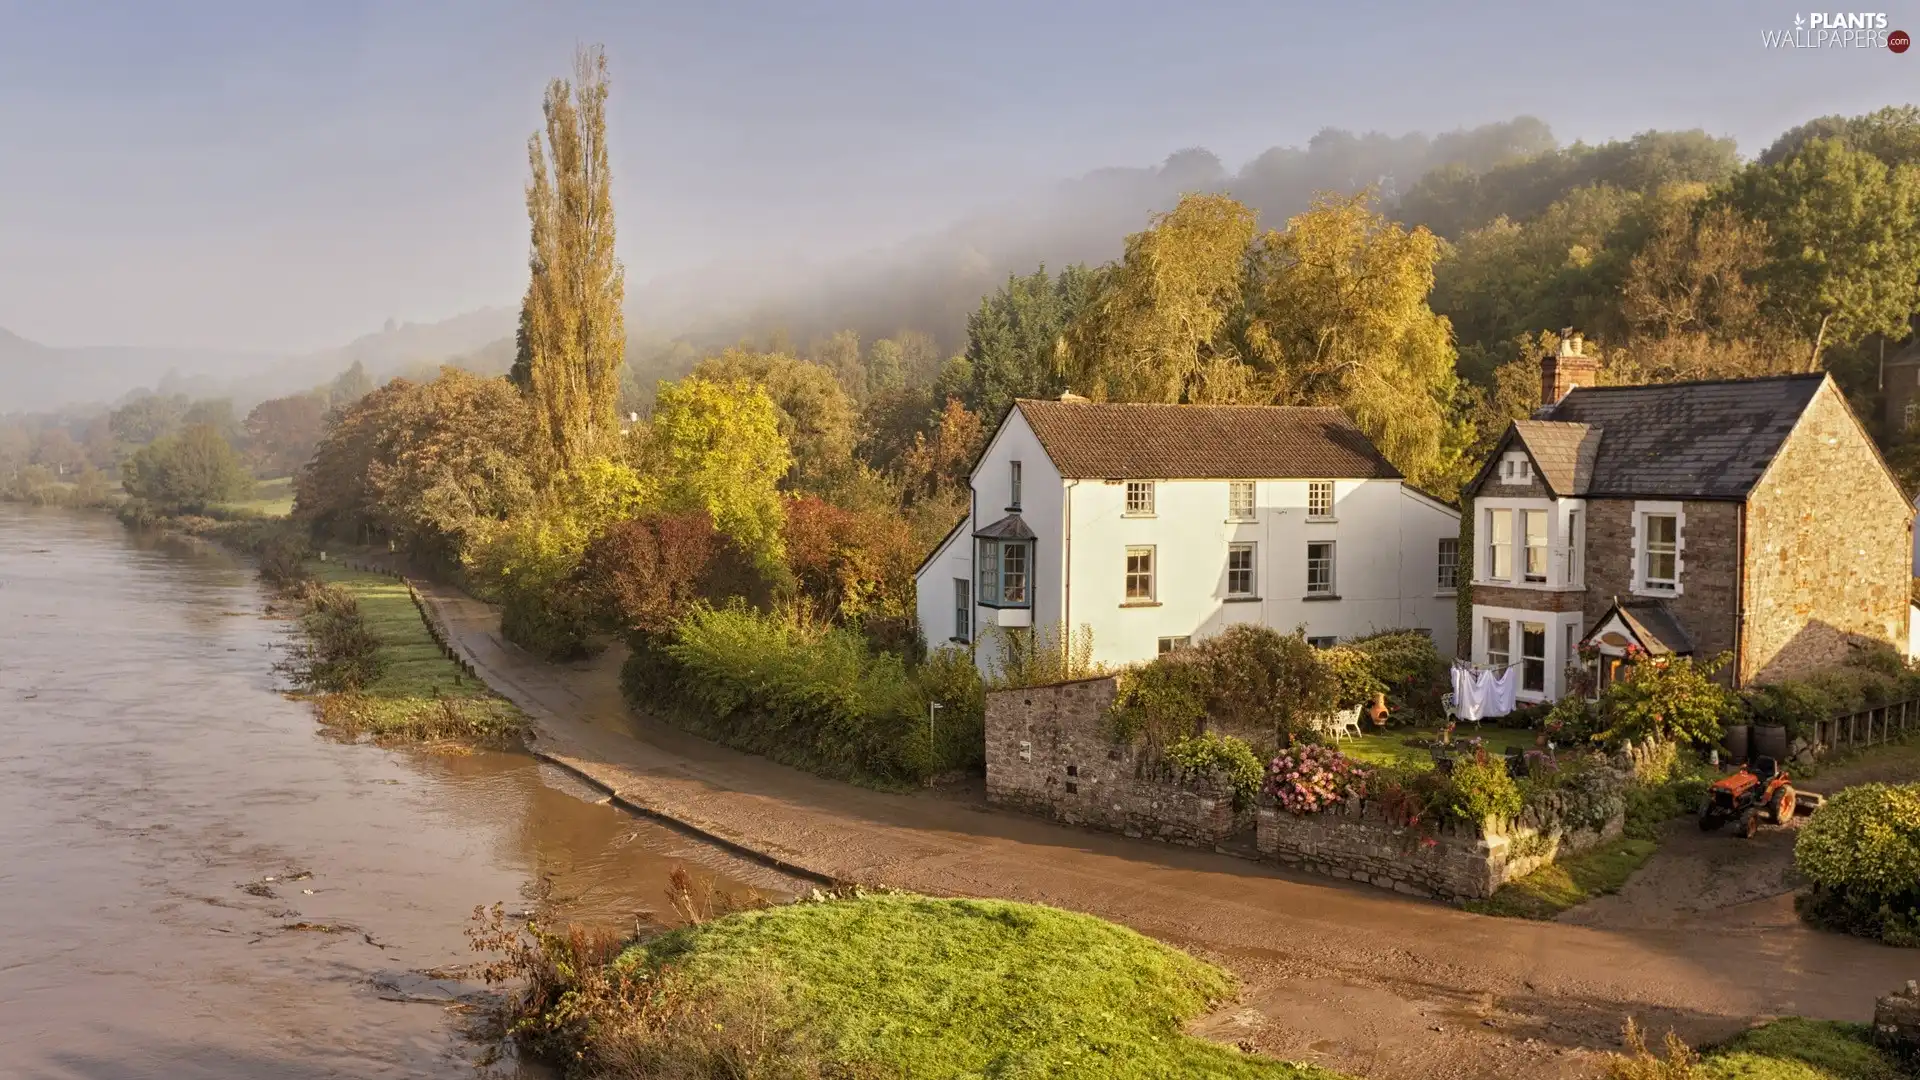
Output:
[987, 676, 1252, 847]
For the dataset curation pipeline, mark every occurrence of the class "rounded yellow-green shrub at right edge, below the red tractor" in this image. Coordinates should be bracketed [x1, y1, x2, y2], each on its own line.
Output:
[1793, 772, 1920, 945]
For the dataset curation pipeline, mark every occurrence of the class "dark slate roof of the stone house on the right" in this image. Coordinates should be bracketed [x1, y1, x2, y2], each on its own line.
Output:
[1513, 375, 1826, 500]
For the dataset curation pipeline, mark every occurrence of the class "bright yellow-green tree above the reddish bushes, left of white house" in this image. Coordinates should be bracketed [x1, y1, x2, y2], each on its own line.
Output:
[645, 377, 793, 559]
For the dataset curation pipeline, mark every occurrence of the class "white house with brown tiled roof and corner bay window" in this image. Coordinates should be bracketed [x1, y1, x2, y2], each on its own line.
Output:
[916, 396, 1459, 669]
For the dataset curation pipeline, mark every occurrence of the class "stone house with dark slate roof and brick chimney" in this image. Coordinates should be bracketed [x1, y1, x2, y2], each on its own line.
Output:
[1461, 334, 1914, 701]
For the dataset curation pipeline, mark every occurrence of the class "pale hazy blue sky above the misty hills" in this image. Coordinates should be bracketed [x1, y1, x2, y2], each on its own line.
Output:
[0, 0, 1920, 350]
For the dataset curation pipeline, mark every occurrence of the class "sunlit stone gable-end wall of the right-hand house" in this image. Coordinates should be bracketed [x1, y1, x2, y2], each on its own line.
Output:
[1751, 382, 1912, 682]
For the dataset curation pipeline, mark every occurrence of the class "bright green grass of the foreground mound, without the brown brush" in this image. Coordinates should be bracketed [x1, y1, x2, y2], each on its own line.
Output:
[618, 894, 1338, 1080]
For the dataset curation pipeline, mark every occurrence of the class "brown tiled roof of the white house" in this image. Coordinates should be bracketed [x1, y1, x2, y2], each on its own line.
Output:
[1018, 400, 1400, 480]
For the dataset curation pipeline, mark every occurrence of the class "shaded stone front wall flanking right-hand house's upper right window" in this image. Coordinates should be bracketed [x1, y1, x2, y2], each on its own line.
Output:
[1582, 500, 1740, 678]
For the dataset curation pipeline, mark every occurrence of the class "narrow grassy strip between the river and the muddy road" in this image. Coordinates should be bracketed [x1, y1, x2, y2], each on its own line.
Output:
[291, 561, 526, 746]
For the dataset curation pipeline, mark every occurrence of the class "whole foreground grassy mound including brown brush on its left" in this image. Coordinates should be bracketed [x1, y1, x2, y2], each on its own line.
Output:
[480, 894, 1340, 1080]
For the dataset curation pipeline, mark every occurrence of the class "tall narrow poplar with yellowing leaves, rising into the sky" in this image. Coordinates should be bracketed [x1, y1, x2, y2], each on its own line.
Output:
[522, 46, 626, 471]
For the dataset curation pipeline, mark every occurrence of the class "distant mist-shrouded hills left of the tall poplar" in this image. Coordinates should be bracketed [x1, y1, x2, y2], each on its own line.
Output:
[0, 307, 516, 413]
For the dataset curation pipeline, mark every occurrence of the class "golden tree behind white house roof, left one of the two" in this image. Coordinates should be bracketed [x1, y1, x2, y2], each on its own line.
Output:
[1062, 194, 1254, 402]
